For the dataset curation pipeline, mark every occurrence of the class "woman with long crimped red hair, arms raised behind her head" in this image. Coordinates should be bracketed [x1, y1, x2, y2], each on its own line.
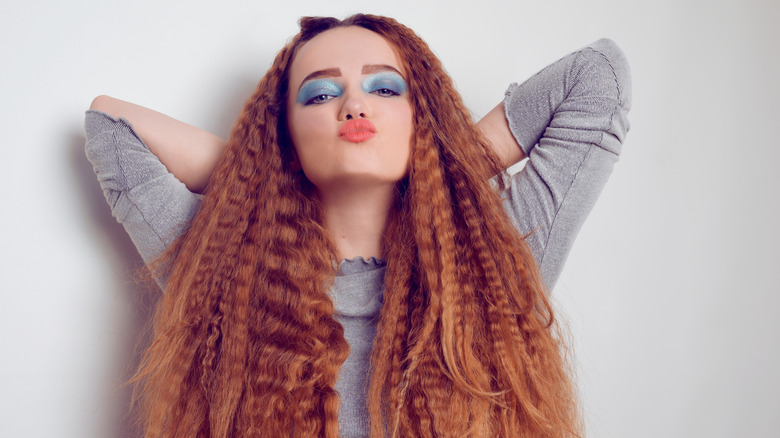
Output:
[86, 15, 630, 437]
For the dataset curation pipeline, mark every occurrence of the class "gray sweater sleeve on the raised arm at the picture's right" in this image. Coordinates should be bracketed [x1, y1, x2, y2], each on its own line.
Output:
[504, 39, 631, 290]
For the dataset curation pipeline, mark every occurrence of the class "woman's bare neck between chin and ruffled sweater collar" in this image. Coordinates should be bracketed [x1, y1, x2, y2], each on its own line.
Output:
[319, 184, 396, 260]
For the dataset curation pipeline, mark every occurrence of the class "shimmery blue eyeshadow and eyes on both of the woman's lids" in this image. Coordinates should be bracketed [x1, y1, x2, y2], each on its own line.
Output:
[296, 71, 407, 105]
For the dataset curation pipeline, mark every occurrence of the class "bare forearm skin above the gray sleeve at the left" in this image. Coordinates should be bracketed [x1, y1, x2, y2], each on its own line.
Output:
[90, 96, 226, 193]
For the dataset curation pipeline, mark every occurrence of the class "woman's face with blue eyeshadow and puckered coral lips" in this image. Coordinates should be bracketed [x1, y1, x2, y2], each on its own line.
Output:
[287, 26, 412, 190]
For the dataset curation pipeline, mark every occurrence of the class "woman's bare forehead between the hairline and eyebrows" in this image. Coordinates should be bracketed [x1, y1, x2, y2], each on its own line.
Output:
[290, 26, 404, 86]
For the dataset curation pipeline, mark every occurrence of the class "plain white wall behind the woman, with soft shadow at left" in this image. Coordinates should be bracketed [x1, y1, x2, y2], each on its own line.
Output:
[0, 0, 780, 438]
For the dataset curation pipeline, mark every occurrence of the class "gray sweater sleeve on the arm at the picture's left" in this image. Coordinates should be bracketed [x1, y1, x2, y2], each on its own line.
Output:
[85, 110, 200, 263]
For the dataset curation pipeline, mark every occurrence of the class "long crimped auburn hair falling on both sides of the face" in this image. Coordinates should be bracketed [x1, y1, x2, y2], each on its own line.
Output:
[134, 14, 581, 438]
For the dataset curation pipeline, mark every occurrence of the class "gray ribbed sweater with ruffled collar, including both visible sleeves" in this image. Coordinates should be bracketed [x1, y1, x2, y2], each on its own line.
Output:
[86, 40, 631, 438]
